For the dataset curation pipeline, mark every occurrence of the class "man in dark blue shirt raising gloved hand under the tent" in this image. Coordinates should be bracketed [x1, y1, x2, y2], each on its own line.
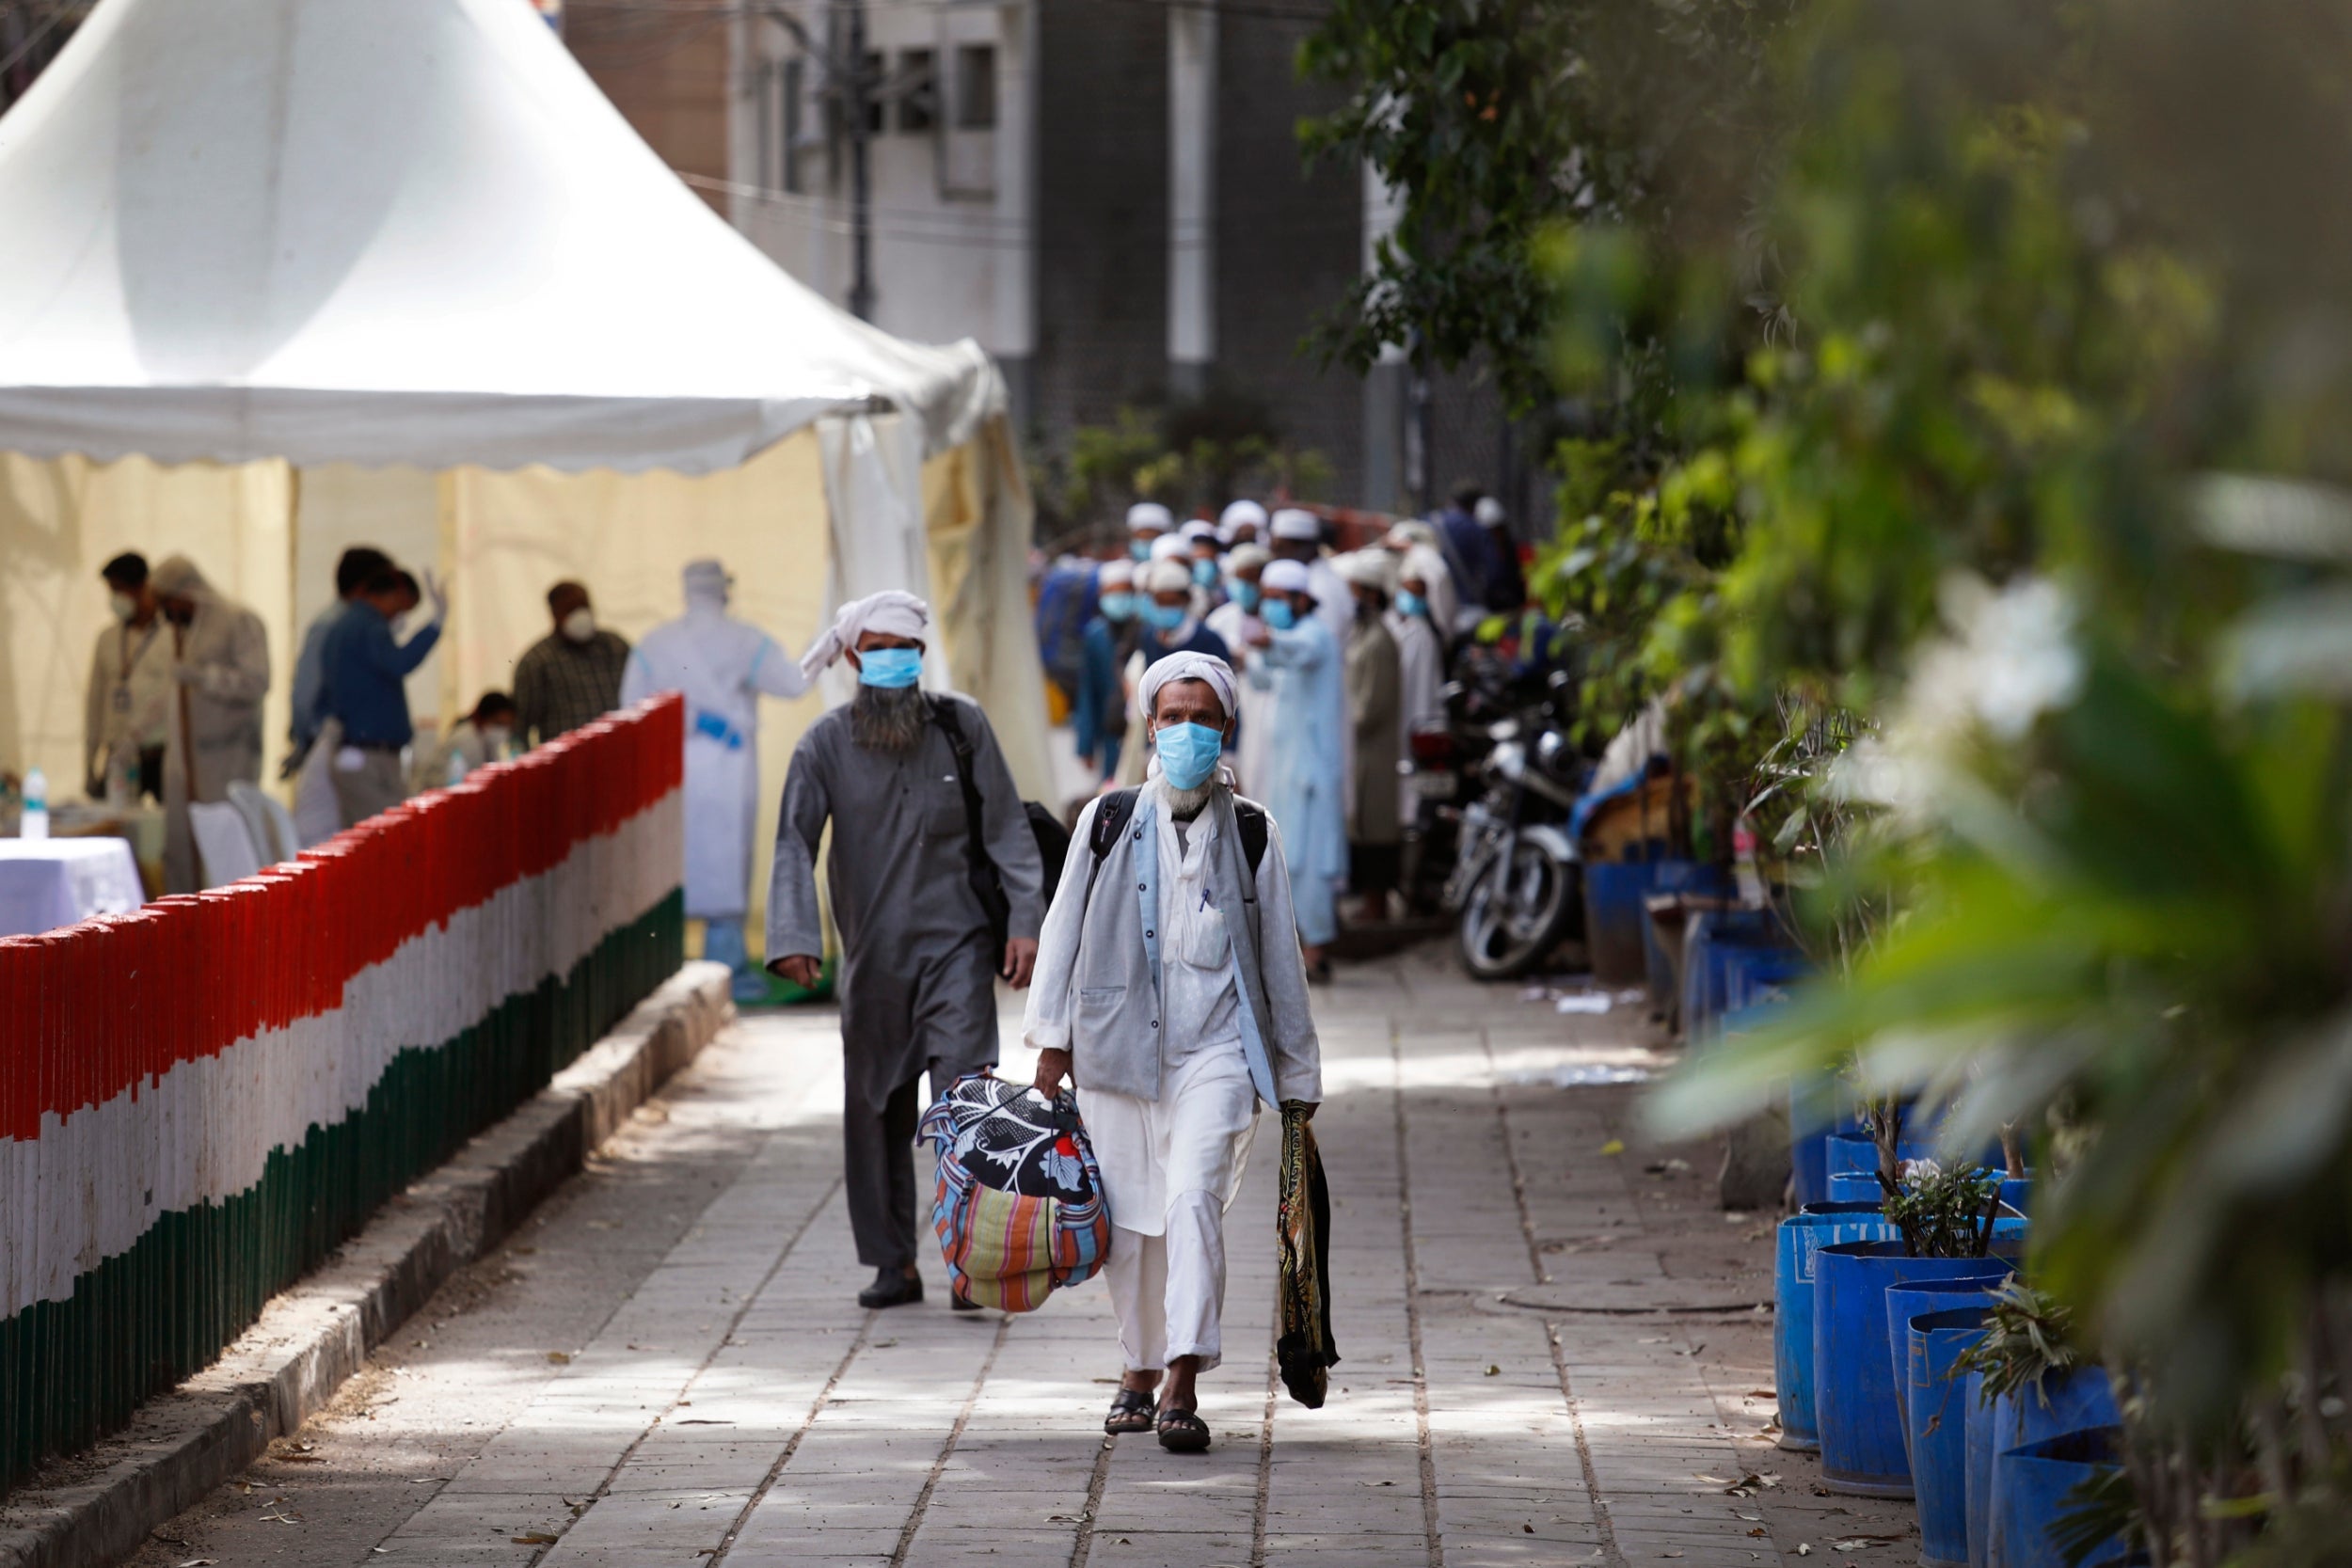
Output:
[320, 566, 450, 828]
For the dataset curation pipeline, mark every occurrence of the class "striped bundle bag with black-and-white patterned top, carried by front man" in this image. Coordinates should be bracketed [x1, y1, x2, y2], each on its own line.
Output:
[920, 1072, 1110, 1312]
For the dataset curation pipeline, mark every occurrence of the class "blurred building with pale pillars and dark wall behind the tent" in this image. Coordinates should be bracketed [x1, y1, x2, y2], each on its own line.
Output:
[564, 0, 1524, 526]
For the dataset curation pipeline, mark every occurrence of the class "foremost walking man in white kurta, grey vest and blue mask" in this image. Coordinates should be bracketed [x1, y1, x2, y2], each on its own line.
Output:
[1024, 654, 1322, 1453]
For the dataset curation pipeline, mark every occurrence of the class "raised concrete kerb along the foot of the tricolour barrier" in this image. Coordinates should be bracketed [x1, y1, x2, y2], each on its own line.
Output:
[0, 964, 734, 1568]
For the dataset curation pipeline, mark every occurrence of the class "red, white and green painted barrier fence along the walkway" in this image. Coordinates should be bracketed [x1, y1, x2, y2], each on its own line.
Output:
[0, 696, 685, 1483]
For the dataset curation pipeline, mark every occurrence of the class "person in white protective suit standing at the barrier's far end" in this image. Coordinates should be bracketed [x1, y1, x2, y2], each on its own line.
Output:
[621, 560, 809, 999]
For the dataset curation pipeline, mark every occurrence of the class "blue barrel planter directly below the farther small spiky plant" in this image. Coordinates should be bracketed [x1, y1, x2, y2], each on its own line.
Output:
[1814, 1242, 2013, 1497]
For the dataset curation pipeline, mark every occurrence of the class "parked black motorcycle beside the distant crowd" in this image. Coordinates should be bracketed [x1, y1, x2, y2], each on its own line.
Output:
[1444, 684, 1590, 980]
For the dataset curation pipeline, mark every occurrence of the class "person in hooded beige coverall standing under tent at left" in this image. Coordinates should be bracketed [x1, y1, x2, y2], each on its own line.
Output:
[149, 555, 271, 894]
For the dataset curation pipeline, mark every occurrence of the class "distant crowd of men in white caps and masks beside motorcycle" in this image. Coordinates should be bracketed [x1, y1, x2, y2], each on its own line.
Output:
[1071, 484, 1527, 980]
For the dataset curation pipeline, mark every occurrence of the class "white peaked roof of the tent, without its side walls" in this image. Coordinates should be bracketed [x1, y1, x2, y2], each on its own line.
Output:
[0, 0, 1002, 472]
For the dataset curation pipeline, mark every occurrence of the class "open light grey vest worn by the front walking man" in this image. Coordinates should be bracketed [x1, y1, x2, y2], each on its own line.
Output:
[1071, 790, 1278, 1105]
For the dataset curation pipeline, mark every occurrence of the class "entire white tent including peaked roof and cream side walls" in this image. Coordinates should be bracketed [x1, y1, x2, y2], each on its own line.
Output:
[0, 0, 1052, 921]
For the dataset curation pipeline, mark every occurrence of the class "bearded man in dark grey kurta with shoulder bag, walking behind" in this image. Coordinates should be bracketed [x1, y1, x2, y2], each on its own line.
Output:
[767, 593, 1044, 1307]
